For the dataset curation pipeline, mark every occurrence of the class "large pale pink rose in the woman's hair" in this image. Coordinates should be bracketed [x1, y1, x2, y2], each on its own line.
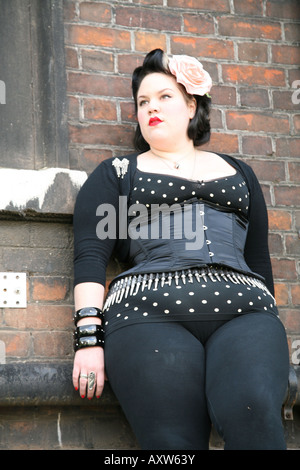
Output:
[168, 55, 212, 96]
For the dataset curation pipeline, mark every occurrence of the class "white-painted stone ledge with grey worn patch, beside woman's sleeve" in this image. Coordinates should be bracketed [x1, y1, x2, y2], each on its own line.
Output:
[0, 168, 87, 215]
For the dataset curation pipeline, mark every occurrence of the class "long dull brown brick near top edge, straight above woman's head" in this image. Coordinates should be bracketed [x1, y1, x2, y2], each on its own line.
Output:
[115, 6, 181, 31]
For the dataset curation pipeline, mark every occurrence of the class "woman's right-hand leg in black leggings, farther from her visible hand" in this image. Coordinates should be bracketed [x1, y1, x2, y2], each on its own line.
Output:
[206, 313, 289, 450]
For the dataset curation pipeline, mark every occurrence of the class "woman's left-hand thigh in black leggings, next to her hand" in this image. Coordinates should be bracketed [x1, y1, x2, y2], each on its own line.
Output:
[105, 323, 210, 449]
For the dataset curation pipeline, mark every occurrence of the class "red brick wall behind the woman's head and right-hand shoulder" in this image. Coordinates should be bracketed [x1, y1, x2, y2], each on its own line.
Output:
[65, 0, 300, 360]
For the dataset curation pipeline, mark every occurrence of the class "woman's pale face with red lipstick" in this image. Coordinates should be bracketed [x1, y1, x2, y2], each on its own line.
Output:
[137, 73, 196, 151]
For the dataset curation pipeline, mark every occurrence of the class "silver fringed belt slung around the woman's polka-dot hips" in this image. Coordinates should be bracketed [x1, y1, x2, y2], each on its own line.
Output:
[103, 267, 273, 310]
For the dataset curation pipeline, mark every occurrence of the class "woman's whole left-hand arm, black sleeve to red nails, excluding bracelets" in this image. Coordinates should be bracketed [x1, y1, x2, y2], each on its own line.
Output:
[73, 161, 119, 399]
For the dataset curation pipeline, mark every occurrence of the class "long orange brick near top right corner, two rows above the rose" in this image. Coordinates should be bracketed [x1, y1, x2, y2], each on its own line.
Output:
[218, 16, 281, 40]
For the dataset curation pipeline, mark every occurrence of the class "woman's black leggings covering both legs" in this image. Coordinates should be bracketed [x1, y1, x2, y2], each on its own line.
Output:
[105, 313, 289, 450]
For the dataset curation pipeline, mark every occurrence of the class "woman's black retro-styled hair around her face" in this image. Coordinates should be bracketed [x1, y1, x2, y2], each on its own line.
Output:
[131, 49, 211, 152]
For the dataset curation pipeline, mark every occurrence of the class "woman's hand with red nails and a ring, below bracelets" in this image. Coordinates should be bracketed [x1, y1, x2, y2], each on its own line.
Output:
[73, 346, 105, 400]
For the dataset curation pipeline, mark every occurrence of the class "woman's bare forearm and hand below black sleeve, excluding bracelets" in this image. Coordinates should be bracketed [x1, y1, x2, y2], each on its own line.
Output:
[73, 282, 105, 399]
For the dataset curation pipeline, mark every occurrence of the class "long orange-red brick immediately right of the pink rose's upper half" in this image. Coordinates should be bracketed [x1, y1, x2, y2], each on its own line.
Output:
[222, 64, 285, 87]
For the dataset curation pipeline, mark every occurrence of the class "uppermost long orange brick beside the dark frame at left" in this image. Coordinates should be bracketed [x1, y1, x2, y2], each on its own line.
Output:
[65, 25, 131, 49]
